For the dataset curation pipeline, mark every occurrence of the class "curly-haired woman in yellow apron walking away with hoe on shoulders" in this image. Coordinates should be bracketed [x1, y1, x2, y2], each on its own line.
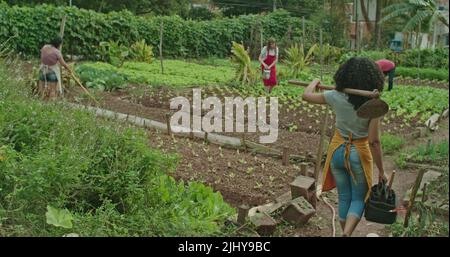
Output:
[303, 57, 386, 236]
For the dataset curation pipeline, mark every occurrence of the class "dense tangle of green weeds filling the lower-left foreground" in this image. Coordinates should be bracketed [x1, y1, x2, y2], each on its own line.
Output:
[0, 62, 234, 236]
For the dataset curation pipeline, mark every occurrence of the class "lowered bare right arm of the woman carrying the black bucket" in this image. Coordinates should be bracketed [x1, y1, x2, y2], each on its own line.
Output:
[369, 118, 386, 181]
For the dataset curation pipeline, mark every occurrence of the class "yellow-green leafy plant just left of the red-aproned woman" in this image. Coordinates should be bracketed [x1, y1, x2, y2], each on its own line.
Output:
[231, 41, 256, 85]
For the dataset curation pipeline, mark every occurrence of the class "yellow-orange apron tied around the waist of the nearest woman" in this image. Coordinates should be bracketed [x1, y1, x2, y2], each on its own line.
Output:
[322, 130, 373, 201]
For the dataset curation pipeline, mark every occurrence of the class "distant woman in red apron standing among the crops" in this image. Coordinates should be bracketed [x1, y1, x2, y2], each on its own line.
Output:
[259, 38, 278, 93]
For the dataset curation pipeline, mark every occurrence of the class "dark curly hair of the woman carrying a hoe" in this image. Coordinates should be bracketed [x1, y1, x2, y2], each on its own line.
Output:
[333, 57, 384, 110]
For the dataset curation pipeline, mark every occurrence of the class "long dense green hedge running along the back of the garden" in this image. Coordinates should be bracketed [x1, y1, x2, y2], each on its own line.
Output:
[0, 5, 324, 60]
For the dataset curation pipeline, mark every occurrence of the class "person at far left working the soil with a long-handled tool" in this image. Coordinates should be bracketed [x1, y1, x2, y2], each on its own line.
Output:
[39, 37, 72, 100]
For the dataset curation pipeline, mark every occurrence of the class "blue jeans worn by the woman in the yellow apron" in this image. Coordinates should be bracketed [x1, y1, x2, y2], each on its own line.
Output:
[331, 145, 368, 221]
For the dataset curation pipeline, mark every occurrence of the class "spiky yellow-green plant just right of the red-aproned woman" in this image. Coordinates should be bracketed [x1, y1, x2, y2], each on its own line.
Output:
[284, 43, 317, 78]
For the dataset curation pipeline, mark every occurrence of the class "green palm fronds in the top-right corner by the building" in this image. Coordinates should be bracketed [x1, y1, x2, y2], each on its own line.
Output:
[380, 0, 448, 32]
